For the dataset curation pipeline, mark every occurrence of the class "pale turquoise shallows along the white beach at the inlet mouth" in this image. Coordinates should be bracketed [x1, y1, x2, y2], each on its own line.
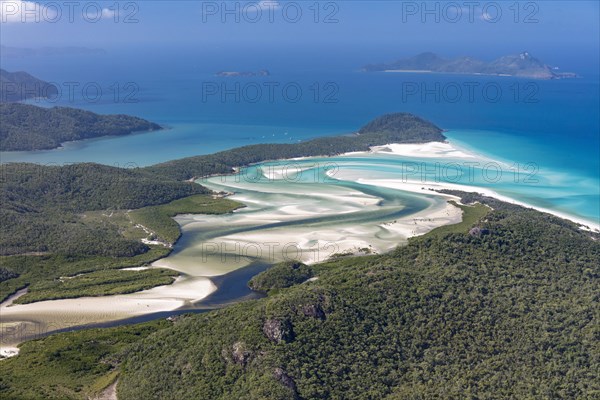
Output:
[258, 151, 600, 223]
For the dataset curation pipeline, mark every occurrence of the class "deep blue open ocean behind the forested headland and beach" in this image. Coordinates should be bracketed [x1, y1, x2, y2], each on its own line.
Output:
[0, 48, 600, 222]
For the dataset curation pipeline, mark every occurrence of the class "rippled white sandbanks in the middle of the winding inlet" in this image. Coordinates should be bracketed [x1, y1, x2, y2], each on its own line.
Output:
[173, 167, 462, 270]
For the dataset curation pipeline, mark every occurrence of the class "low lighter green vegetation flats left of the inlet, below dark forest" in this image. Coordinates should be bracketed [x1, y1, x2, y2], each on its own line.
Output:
[0, 195, 241, 303]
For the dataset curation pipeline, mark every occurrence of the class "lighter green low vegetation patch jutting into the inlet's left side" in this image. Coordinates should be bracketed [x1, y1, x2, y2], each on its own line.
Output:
[129, 195, 243, 243]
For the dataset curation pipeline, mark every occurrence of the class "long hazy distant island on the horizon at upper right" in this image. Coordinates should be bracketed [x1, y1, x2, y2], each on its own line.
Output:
[363, 51, 577, 79]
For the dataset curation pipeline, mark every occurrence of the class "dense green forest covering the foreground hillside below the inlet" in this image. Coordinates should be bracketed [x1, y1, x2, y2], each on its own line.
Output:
[0, 192, 600, 400]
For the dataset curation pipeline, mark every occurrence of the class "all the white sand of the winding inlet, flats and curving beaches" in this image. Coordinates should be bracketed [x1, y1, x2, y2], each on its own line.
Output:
[0, 142, 600, 355]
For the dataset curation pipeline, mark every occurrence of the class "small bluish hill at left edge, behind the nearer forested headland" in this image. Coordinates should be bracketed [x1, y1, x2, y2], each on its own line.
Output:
[0, 69, 58, 103]
